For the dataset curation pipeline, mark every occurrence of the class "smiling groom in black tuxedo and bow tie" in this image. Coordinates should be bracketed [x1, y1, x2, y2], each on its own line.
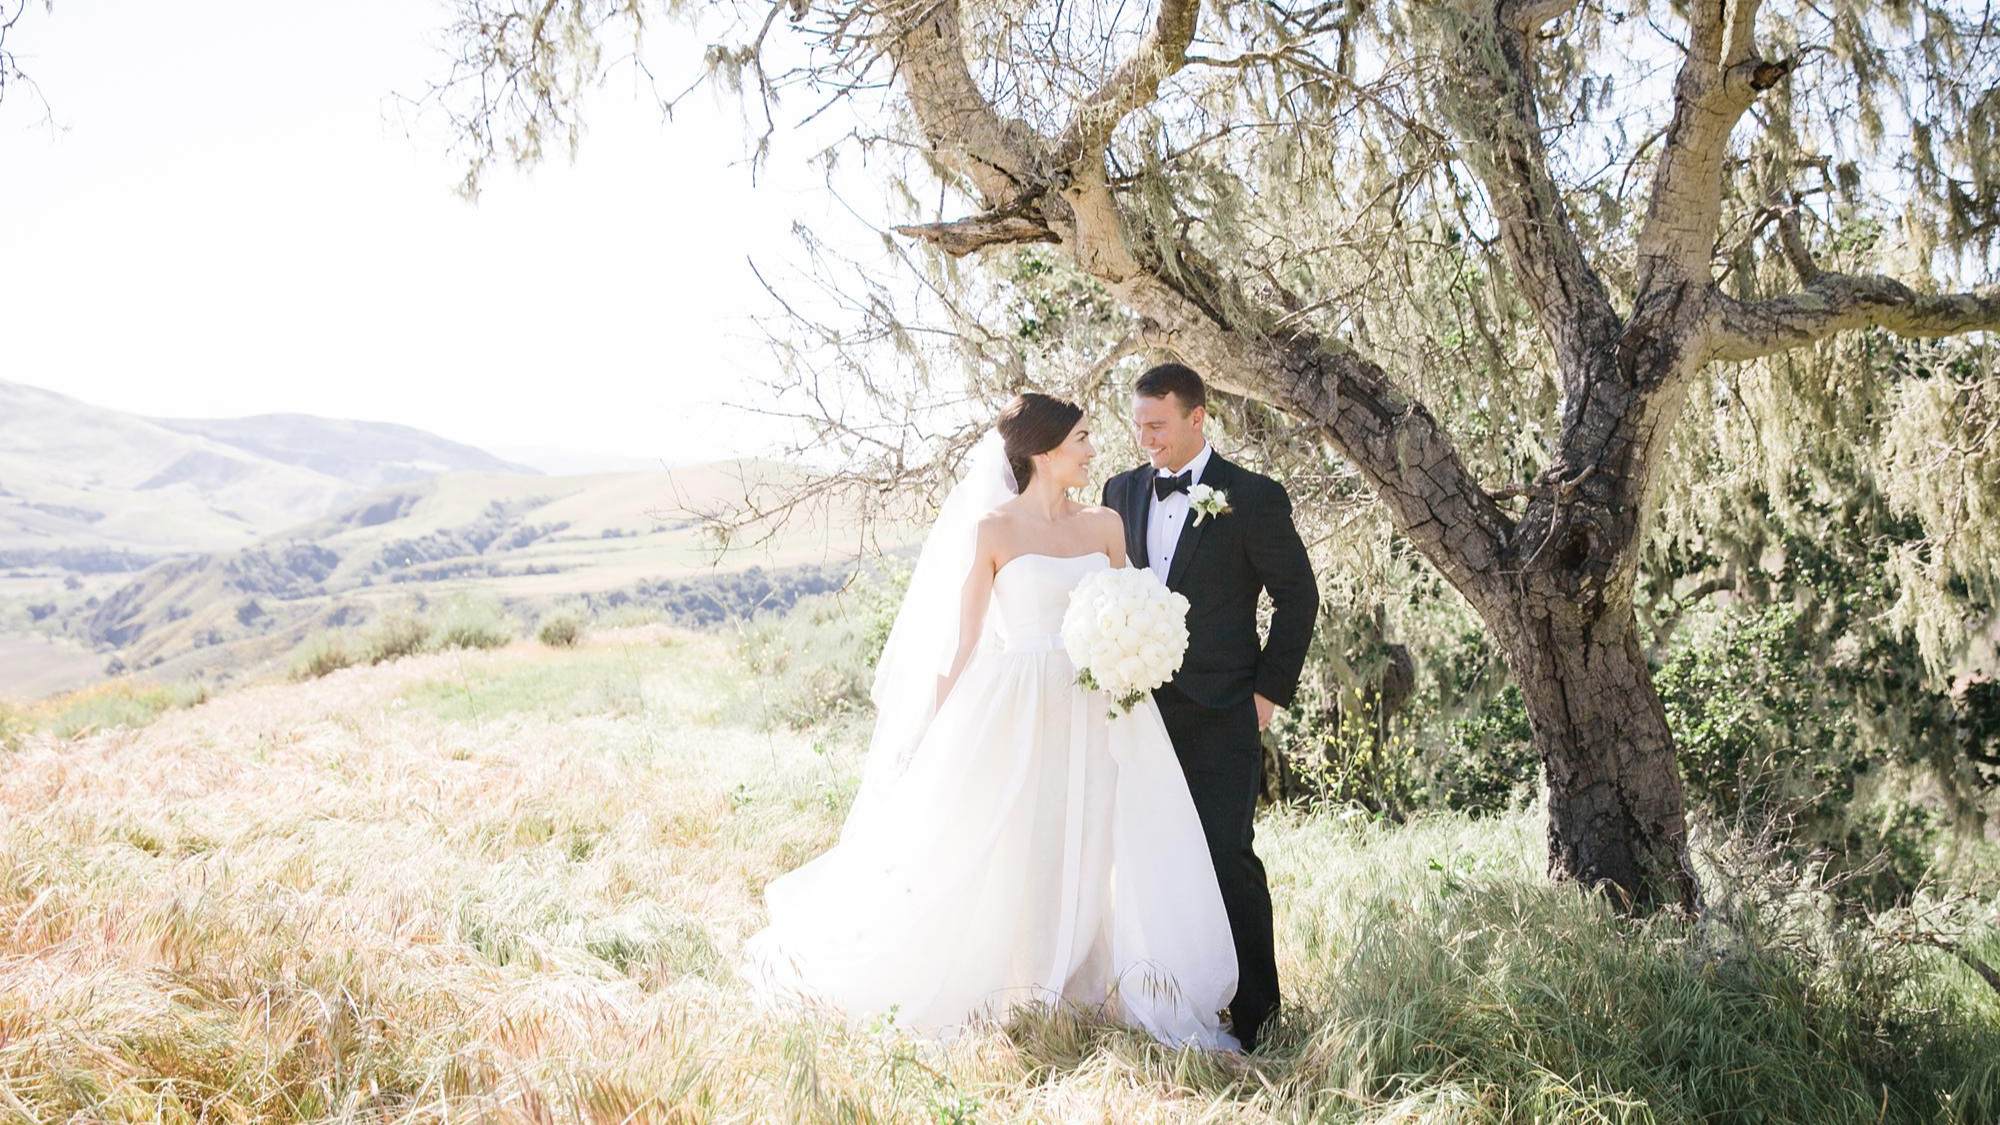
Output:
[1104, 362, 1320, 1051]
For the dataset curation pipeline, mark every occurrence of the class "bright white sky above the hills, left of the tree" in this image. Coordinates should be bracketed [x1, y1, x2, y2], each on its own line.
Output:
[0, 0, 876, 460]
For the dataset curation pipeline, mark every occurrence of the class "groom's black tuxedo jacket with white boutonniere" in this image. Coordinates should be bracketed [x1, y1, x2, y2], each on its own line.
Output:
[1104, 452, 1320, 707]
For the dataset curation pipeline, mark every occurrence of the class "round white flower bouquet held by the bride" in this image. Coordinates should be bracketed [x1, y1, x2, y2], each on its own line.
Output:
[1062, 567, 1188, 719]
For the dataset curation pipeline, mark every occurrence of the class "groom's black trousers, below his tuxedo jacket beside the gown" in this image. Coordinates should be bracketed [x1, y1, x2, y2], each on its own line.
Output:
[1152, 685, 1278, 1047]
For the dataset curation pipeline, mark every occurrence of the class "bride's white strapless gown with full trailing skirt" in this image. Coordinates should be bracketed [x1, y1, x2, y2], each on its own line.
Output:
[742, 554, 1236, 1049]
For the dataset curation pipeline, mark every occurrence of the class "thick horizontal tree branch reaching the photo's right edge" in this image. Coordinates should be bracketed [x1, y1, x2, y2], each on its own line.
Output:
[1708, 272, 2000, 360]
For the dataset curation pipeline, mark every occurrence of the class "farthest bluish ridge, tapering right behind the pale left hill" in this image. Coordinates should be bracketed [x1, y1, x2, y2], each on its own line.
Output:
[148, 414, 542, 488]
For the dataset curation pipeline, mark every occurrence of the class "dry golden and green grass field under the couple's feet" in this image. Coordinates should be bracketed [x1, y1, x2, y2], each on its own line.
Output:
[0, 627, 2000, 1123]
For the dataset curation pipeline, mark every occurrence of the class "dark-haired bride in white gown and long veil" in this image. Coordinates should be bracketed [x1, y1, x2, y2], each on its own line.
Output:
[742, 392, 1236, 1049]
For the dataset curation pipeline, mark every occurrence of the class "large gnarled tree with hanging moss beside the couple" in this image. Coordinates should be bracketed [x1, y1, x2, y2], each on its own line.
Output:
[434, 0, 2000, 909]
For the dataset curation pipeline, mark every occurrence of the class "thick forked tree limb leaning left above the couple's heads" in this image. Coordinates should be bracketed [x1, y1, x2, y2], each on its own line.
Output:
[892, 0, 1504, 591]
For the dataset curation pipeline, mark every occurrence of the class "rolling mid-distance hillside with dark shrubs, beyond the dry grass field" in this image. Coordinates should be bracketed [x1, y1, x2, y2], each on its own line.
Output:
[0, 460, 916, 699]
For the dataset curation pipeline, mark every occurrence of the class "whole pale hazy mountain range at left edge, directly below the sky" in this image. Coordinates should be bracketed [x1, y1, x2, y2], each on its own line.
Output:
[0, 380, 536, 560]
